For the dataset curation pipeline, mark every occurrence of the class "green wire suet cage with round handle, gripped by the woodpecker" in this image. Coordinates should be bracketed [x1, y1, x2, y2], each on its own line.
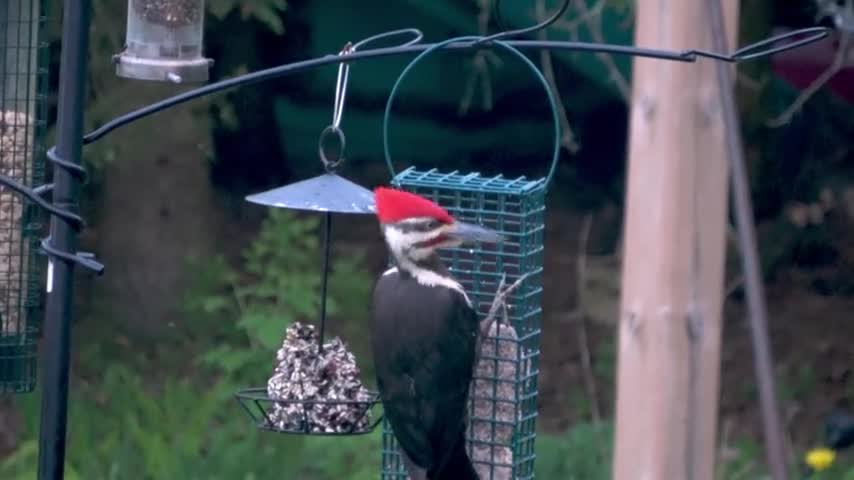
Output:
[381, 37, 560, 480]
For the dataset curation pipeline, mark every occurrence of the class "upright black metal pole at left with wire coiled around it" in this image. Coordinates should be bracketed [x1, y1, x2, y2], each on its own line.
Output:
[38, 0, 90, 480]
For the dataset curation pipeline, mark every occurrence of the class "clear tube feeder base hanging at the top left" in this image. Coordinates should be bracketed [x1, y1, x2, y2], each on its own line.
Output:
[113, 0, 213, 83]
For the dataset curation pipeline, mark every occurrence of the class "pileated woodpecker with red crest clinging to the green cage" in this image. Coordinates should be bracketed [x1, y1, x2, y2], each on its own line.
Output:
[371, 187, 502, 480]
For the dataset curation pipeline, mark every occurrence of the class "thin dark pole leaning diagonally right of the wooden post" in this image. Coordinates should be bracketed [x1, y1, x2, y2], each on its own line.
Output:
[707, 0, 789, 480]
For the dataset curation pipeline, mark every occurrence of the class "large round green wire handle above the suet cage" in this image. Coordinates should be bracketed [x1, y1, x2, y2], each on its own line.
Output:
[383, 36, 561, 186]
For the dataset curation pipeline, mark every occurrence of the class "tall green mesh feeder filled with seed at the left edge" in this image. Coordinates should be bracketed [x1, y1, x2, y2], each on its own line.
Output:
[0, 0, 47, 394]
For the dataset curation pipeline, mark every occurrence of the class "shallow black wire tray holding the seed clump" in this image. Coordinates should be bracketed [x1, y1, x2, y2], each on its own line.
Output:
[234, 387, 383, 436]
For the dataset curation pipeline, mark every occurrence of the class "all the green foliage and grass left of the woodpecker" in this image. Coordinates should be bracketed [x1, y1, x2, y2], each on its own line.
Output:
[0, 210, 381, 480]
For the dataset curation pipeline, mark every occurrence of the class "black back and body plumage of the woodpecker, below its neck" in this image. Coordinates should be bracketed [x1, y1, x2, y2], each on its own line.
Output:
[371, 264, 478, 480]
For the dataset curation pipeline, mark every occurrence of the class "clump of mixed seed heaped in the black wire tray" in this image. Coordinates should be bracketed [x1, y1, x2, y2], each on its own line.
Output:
[267, 323, 372, 433]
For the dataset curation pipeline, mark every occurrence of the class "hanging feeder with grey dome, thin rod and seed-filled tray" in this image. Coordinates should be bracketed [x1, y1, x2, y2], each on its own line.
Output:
[236, 47, 381, 435]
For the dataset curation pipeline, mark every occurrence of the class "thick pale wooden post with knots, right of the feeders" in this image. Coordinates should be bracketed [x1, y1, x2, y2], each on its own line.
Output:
[613, 0, 738, 480]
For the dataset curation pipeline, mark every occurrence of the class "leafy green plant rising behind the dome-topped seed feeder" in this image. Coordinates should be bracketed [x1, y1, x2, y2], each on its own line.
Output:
[186, 209, 371, 382]
